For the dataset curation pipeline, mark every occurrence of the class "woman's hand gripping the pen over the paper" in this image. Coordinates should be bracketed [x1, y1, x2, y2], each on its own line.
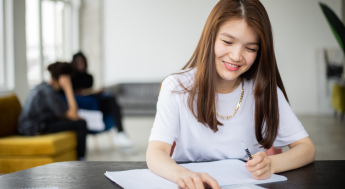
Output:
[244, 151, 273, 180]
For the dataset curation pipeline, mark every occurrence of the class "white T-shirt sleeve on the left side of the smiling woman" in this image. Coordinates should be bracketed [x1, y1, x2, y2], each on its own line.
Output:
[149, 75, 181, 144]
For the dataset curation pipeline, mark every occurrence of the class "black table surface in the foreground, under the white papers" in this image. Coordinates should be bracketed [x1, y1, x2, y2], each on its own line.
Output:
[0, 160, 345, 189]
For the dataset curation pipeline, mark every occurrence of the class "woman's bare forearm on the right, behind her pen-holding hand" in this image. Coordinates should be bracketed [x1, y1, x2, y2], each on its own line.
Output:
[268, 143, 315, 173]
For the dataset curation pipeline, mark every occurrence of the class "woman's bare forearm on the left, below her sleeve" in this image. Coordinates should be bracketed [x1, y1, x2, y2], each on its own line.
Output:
[146, 146, 189, 183]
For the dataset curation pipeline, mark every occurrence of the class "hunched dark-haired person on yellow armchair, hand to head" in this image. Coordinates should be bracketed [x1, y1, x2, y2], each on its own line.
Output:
[18, 62, 87, 160]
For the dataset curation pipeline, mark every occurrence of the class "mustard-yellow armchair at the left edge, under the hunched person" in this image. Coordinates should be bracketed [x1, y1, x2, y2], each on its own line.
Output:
[0, 95, 77, 173]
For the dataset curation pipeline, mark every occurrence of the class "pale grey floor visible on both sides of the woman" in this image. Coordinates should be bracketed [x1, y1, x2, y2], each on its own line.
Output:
[86, 116, 345, 161]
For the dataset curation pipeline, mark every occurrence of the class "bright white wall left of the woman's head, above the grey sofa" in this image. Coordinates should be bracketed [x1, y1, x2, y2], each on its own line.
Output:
[103, 0, 217, 85]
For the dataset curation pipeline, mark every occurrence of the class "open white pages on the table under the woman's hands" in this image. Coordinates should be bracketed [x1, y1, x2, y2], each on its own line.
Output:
[105, 159, 287, 189]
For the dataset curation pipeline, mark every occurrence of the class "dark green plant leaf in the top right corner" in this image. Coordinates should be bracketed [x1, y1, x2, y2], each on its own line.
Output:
[319, 2, 345, 55]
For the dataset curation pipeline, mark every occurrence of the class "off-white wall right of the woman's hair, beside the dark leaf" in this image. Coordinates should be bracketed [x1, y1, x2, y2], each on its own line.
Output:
[262, 0, 341, 114]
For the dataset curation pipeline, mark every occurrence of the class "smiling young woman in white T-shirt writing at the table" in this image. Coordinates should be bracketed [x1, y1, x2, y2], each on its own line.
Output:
[146, 0, 315, 189]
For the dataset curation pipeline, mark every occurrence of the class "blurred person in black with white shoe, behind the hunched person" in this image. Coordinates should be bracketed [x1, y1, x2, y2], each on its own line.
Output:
[71, 52, 133, 147]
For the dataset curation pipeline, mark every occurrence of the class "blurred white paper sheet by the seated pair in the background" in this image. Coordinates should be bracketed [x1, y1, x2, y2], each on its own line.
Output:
[78, 109, 105, 131]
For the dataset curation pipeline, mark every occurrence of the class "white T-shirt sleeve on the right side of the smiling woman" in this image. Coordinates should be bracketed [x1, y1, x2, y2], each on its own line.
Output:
[273, 87, 309, 148]
